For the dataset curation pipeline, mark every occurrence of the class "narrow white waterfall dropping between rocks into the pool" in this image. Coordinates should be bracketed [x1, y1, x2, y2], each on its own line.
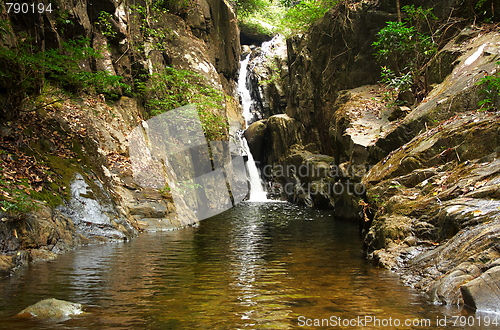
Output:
[238, 54, 268, 202]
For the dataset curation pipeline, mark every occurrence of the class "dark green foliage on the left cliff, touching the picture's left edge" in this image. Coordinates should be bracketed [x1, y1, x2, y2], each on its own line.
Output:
[0, 39, 129, 118]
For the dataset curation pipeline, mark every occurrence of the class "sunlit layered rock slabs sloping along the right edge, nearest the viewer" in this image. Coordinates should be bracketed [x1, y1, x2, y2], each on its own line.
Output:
[363, 28, 500, 311]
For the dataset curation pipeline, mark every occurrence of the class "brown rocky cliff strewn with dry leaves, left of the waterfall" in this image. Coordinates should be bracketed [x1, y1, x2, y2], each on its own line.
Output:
[0, 0, 242, 274]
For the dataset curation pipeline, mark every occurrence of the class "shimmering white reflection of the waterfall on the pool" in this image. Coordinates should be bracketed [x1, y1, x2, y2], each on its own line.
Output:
[230, 204, 292, 329]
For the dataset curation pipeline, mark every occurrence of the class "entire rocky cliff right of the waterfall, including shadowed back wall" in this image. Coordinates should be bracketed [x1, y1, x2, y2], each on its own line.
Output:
[243, 1, 500, 311]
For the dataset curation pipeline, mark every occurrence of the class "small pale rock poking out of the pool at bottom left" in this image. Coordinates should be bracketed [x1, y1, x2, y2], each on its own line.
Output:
[17, 298, 84, 318]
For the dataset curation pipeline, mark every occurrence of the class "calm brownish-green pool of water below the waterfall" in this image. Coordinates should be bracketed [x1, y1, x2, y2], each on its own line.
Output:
[0, 203, 492, 329]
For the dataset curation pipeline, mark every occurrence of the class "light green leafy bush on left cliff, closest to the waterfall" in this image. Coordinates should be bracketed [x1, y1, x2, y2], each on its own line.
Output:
[141, 67, 228, 140]
